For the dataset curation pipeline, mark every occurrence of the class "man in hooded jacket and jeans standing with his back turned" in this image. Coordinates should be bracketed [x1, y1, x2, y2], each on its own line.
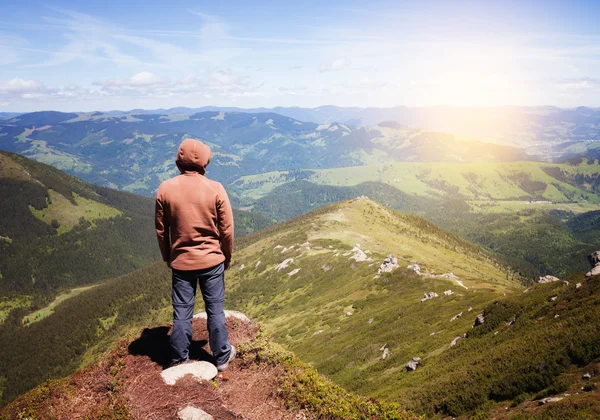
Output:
[155, 139, 236, 371]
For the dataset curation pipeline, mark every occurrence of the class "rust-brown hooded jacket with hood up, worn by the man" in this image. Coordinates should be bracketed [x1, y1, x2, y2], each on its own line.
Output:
[155, 139, 233, 271]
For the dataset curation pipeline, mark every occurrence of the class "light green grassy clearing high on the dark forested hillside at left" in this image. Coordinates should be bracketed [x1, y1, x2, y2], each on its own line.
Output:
[29, 190, 122, 234]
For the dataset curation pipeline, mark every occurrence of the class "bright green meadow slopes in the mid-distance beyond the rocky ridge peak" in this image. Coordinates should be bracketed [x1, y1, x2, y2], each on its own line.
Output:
[234, 162, 600, 211]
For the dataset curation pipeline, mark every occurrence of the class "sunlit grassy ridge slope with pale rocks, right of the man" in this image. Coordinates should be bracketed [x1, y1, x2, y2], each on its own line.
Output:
[229, 199, 522, 412]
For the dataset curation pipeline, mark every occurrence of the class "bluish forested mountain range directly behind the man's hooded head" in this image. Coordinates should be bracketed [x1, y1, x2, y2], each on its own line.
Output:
[0, 111, 531, 195]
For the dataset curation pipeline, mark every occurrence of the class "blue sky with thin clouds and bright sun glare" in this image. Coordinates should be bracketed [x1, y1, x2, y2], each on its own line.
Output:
[0, 0, 600, 112]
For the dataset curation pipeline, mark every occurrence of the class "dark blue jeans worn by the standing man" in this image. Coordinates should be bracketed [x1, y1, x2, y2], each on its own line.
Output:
[170, 264, 231, 366]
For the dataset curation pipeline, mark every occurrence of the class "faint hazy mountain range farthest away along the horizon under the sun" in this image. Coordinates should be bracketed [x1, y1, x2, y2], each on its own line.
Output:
[105, 105, 600, 160]
